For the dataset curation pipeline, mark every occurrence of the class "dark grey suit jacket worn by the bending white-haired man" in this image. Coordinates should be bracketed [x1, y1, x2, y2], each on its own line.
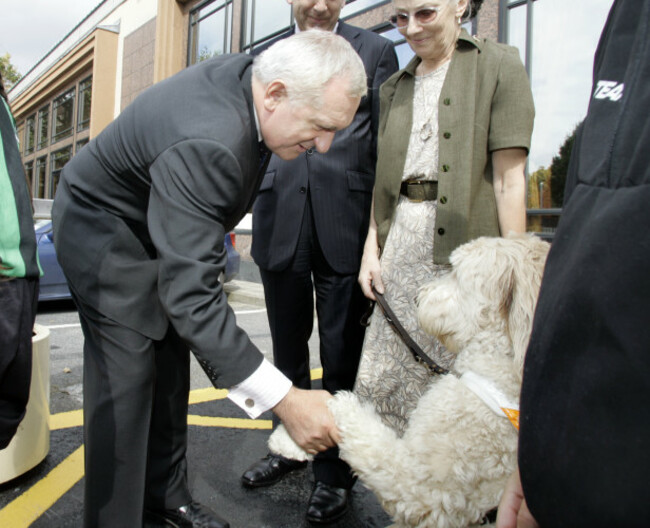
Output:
[52, 55, 263, 387]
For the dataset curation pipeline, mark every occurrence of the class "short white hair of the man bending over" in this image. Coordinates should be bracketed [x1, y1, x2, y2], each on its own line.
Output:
[253, 29, 368, 108]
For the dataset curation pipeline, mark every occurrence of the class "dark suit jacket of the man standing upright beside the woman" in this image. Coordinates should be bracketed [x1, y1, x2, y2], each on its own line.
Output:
[251, 21, 398, 274]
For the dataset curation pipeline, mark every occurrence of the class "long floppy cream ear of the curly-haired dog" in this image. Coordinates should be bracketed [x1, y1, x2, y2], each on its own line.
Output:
[506, 235, 550, 371]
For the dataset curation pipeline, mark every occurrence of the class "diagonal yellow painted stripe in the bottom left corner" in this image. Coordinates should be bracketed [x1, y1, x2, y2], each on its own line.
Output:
[0, 446, 84, 528]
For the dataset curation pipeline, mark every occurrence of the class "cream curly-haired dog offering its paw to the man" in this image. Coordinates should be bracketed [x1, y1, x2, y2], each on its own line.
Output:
[269, 235, 549, 528]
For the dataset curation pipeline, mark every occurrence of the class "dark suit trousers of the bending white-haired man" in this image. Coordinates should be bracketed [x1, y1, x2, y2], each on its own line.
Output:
[75, 299, 191, 528]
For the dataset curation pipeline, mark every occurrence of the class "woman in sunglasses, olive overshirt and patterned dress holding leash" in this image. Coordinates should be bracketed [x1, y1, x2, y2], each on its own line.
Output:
[355, 0, 534, 433]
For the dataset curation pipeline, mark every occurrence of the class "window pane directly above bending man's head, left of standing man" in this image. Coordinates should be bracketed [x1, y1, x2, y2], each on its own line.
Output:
[243, 0, 293, 50]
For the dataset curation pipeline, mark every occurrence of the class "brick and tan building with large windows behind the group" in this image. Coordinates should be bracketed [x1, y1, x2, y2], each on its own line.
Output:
[9, 0, 613, 235]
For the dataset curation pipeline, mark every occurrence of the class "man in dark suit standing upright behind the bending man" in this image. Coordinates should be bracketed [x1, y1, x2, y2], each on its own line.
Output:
[242, 0, 398, 523]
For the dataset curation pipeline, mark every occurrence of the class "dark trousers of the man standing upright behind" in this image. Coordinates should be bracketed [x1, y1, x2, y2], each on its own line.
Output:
[260, 192, 367, 488]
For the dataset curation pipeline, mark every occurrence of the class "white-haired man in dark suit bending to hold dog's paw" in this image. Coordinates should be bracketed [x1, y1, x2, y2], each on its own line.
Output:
[52, 32, 366, 528]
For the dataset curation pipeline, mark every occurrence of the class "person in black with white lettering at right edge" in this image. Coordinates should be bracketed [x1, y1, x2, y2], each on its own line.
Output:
[498, 0, 650, 528]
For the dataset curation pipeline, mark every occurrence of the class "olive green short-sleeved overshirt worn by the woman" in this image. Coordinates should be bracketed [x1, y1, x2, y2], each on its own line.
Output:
[374, 30, 535, 264]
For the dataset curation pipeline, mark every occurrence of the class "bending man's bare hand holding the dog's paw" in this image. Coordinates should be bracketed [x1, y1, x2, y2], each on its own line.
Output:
[273, 387, 341, 455]
